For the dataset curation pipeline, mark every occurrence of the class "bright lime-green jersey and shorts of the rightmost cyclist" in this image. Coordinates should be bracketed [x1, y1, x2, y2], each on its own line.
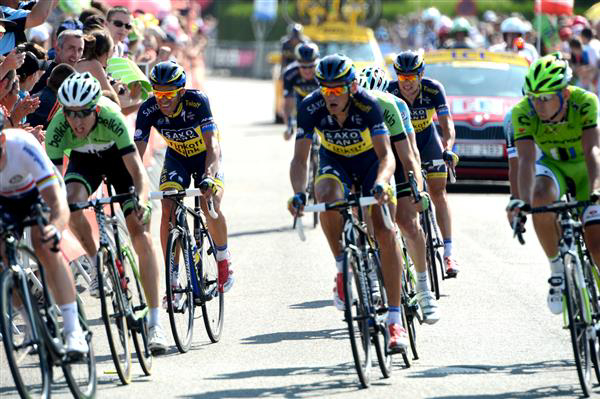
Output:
[512, 86, 598, 212]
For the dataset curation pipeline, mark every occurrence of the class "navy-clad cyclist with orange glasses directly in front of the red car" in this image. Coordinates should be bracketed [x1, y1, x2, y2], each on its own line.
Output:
[388, 50, 458, 277]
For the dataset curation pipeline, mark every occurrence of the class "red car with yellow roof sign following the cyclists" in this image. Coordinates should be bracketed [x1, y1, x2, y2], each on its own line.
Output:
[424, 49, 529, 180]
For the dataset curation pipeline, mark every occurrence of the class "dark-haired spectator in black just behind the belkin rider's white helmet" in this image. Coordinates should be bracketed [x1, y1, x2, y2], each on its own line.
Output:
[27, 64, 75, 130]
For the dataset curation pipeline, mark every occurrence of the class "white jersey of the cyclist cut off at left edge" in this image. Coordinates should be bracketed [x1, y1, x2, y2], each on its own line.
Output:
[0, 129, 59, 199]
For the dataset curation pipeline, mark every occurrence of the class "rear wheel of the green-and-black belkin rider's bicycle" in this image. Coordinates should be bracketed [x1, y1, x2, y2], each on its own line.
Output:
[122, 246, 153, 375]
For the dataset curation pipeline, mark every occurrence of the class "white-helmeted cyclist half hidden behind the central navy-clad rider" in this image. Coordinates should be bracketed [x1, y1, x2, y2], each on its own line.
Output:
[358, 67, 440, 324]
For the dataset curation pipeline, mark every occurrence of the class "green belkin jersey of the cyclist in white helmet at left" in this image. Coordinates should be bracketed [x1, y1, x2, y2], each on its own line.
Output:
[46, 97, 136, 165]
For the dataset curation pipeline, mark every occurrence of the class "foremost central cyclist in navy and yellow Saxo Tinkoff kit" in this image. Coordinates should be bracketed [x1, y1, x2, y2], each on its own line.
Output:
[288, 54, 408, 351]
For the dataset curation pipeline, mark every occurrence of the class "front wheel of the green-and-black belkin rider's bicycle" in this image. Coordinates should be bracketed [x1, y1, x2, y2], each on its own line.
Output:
[97, 248, 131, 385]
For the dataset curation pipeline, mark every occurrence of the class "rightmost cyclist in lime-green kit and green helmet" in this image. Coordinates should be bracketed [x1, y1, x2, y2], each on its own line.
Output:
[507, 52, 600, 314]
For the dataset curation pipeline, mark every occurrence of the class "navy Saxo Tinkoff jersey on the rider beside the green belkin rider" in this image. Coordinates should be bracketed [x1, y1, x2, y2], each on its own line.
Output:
[134, 90, 218, 157]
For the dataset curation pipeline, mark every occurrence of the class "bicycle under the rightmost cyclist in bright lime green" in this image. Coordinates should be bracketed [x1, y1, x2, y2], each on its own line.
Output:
[513, 201, 600, 397]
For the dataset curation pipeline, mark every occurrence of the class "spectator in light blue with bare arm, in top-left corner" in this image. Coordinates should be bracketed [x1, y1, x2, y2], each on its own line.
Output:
[0, 0, 58, 55]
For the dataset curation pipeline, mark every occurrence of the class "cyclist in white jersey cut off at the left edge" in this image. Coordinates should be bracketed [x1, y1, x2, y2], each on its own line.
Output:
[0, 119, 89, 354]
